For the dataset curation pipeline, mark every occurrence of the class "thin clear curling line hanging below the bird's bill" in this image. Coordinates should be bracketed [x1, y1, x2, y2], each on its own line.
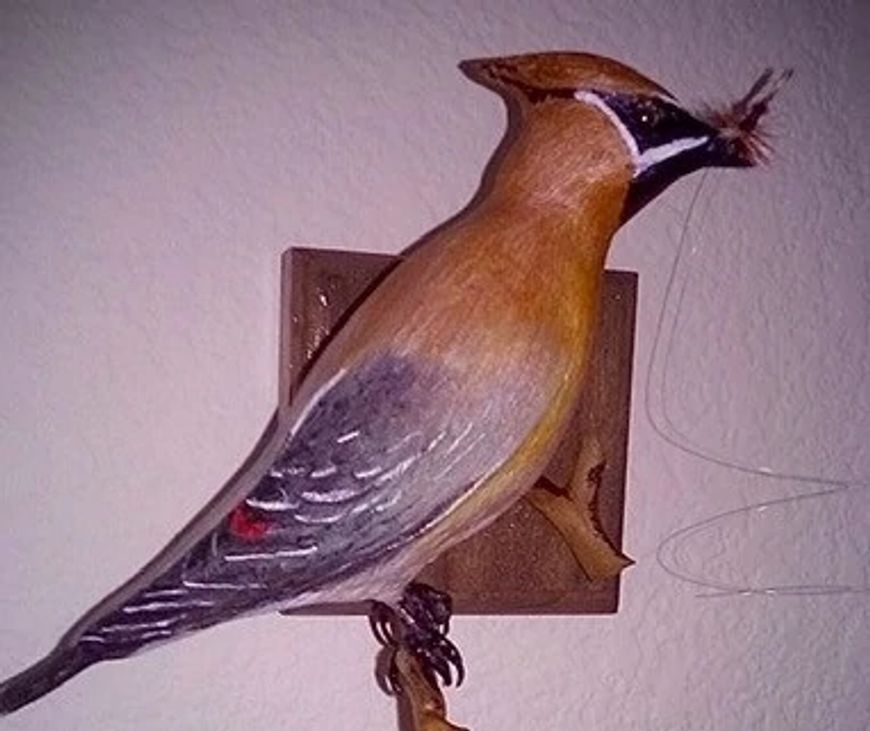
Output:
[644, 171, 870, 597]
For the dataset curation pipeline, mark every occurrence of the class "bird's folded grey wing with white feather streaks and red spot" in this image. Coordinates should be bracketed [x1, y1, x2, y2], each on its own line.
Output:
[75, 356, 518, 655]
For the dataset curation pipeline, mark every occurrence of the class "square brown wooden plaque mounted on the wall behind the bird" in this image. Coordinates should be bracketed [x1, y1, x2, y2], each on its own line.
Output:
[280, 248, 637, 614]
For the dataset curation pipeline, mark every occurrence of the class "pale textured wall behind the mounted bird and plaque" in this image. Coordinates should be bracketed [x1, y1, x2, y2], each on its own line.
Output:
[0, 0, 870, 731]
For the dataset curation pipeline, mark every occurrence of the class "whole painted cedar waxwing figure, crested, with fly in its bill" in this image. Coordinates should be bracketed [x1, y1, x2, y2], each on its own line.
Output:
[0, 53, 784, 713]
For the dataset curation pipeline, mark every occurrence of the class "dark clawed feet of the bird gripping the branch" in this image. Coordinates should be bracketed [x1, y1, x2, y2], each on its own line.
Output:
[370, 582, 465, 691]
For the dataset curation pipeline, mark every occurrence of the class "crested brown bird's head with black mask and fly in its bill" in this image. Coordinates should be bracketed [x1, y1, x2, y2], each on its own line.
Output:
[460, 52, 791, 221]
